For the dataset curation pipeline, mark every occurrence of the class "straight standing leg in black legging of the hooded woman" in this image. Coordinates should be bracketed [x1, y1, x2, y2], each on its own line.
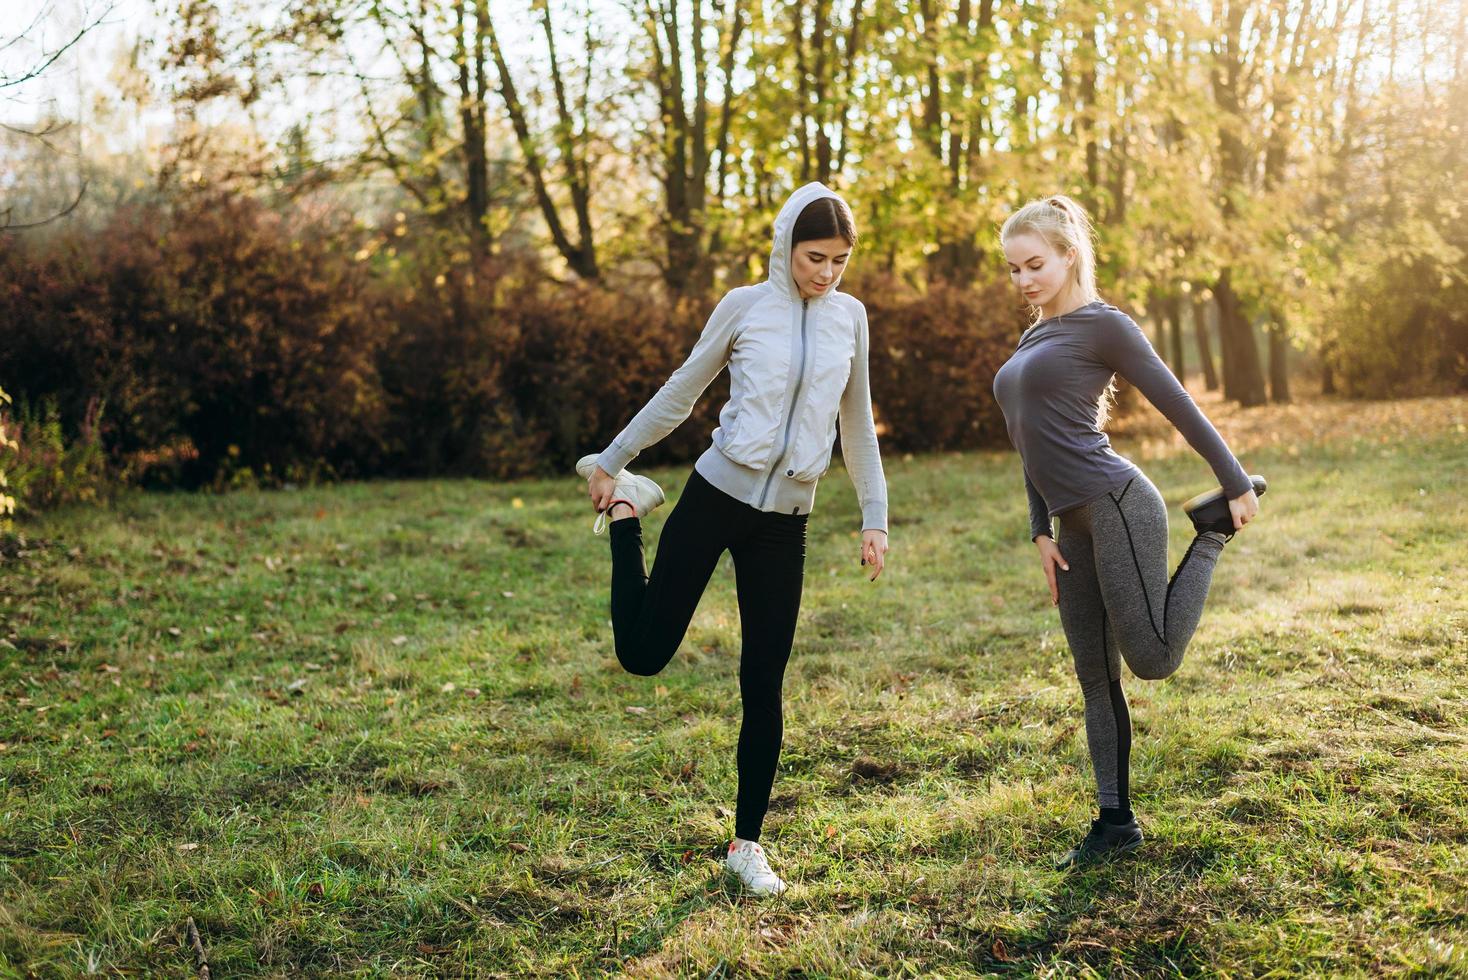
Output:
[730, 513, 806, 841]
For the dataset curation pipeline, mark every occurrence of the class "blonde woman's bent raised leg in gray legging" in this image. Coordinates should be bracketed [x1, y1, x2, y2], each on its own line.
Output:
[1092, 477, 1224, 681]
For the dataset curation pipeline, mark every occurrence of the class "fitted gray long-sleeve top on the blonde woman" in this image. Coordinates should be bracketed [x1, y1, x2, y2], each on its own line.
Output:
[994, 301, 1252, 540]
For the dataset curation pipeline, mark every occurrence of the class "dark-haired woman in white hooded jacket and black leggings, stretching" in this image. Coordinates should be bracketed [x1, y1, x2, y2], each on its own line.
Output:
[575, 183, 887, 895]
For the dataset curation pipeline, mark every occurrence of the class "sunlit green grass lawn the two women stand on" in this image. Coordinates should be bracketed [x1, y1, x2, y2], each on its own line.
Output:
[0, 399, 1468, 977]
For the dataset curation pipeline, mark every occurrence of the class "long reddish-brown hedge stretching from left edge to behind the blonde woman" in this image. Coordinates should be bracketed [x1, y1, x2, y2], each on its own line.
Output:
[0, 195, 1023, 501]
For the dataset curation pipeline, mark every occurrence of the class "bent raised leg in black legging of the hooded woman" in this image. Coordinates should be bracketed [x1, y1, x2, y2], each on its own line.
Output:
[609, 471, 740, 676]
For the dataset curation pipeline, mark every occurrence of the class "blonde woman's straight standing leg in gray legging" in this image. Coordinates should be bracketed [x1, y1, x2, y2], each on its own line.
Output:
[1055, 508, 1132, 823]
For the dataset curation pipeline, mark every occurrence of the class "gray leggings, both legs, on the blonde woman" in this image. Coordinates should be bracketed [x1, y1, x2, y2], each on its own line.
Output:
[1055, 475, 1224, 811]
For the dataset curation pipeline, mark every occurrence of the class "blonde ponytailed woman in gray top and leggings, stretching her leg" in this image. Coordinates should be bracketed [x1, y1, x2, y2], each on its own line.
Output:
[994, 195, 1264, 867]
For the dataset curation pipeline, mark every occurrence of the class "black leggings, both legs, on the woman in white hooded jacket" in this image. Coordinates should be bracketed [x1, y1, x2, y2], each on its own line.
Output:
[611, 471, 807, 841]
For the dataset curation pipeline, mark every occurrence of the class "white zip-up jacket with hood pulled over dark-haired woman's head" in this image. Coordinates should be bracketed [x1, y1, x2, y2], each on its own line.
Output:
[597, 183, 887, 531]
